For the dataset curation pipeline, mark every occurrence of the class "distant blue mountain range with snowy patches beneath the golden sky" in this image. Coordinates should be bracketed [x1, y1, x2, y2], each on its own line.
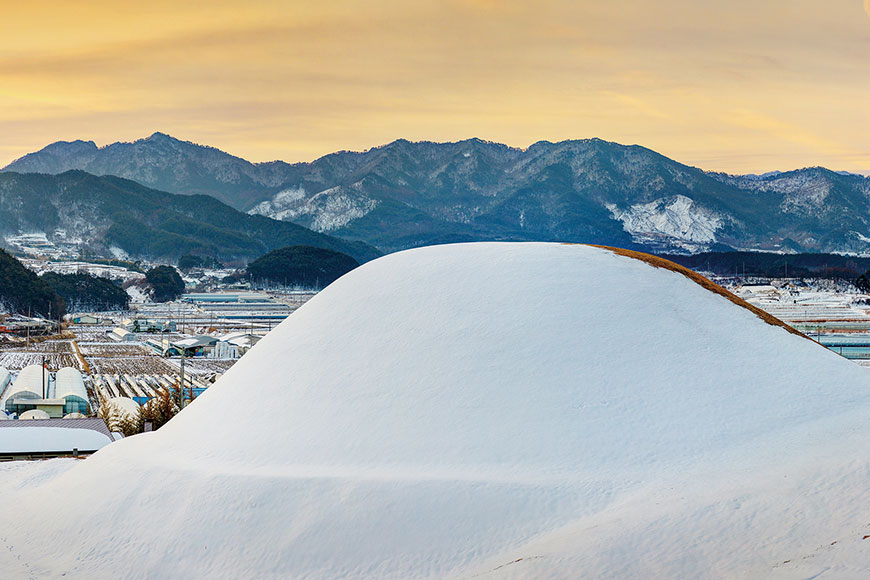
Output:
[3, 133, 870, 254]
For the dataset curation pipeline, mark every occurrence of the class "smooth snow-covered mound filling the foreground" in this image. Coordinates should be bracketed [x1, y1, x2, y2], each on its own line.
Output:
[0, 244, 870, 579]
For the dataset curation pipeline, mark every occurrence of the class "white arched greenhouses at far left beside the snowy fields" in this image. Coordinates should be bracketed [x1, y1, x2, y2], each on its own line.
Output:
[0, 365, 90, 419]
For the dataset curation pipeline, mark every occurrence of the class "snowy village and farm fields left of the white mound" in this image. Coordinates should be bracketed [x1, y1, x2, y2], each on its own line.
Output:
[0, 290, 315, 460]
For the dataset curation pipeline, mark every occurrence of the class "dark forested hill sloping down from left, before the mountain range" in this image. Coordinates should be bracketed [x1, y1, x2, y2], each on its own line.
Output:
[0, 171, 379, 262]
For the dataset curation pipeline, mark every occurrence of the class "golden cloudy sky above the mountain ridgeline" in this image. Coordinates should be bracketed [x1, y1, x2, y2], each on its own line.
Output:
[0, 0, 870, 172]
